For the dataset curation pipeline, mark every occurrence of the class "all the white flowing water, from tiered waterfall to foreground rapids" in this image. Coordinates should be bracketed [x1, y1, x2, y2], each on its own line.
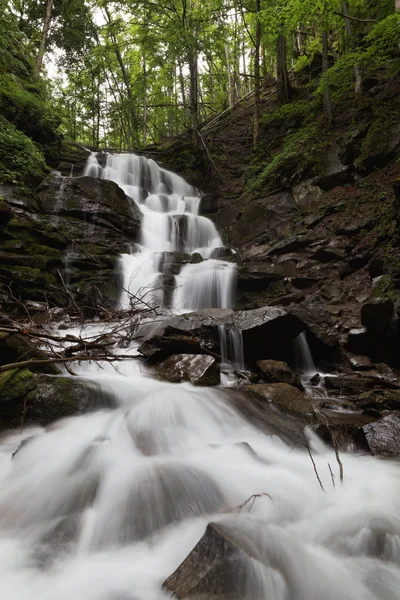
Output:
[0, 155, 400, 600]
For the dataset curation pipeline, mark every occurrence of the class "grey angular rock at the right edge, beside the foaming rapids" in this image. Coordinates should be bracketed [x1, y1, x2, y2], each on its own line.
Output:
[362, 415, 400, 456]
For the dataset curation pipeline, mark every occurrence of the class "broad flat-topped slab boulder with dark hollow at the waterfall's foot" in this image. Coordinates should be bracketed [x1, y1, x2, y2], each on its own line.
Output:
[138, 306, 304, 363]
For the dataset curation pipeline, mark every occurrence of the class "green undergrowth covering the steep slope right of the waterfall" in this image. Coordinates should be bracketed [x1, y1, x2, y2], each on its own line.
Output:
[246, 13, 400, 193]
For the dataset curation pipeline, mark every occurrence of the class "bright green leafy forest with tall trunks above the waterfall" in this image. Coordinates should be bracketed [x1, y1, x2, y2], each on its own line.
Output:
[0, 0, 400, 180]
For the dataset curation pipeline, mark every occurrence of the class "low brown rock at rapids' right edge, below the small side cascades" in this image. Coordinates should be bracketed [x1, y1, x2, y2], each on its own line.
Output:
[246, 383, 314, 422]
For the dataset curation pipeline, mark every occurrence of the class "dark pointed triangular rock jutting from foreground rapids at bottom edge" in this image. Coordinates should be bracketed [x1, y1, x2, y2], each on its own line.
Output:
[163, 523, 265, 600]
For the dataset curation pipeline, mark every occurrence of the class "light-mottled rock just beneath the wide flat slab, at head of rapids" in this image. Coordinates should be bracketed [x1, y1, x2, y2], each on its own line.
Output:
[157, 354, 220, 385]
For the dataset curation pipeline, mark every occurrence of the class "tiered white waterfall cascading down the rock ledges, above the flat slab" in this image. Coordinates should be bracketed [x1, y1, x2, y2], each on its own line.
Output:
[85, 153, 236, 312]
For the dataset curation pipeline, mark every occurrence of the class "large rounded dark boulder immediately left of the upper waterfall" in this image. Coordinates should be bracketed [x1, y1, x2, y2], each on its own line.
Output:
[38, 173, 141, 241]
